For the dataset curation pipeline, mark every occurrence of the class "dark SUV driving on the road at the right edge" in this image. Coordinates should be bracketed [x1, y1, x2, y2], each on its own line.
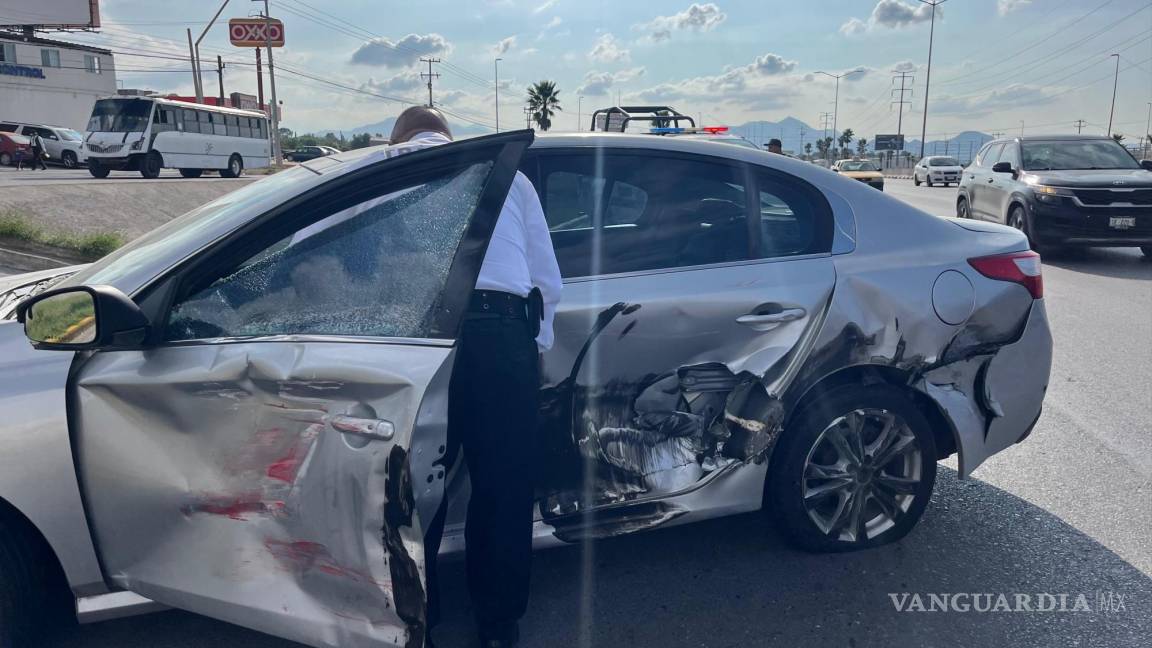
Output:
[956, 135, 1152, 257]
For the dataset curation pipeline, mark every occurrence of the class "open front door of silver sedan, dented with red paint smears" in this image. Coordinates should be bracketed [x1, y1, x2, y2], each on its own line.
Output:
[69, 131, 532, 647]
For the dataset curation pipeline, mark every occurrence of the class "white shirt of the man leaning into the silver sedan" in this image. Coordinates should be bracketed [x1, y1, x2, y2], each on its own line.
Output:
[393, 133, 562, 351]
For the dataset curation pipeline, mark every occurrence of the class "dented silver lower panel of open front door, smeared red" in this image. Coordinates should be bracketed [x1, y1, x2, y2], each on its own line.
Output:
[77, 342, 452, 647]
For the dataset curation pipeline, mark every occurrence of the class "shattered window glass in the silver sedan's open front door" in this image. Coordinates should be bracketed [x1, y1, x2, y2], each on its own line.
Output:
[166, 163, 491, 340]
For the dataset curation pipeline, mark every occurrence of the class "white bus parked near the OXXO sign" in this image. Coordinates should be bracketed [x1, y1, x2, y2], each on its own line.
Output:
[84, 97, 272, 178]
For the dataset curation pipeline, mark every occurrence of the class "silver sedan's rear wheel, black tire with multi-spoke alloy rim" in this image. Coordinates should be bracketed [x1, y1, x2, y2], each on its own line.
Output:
[766, 384, 937, 552]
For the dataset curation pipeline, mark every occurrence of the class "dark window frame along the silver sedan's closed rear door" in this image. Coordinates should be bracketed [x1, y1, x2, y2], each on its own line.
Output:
[521, 145, 838, 284]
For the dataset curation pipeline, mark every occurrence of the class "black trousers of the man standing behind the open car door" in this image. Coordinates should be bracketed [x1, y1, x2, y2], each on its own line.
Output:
[424, 302, 539, 639]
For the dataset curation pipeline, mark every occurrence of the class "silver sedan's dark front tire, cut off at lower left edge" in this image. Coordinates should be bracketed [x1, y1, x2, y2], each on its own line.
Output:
[0, 515, 71, 648]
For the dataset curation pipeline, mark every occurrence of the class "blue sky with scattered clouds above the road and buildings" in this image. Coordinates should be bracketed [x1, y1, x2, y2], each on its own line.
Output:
[76, 0, 1152, 140]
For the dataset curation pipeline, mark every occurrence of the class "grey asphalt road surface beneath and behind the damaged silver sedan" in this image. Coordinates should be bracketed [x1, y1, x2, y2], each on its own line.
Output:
[2, 181, 1152, 648]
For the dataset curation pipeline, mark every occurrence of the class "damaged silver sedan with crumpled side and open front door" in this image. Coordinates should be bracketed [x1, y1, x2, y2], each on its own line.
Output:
[0, 131, 1052, 647]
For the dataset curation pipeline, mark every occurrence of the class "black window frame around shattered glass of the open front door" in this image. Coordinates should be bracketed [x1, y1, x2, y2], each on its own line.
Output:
[132, 131, 532, 348]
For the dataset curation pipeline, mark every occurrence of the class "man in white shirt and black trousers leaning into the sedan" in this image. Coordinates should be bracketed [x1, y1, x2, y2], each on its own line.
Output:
[392, 106, 561, 648]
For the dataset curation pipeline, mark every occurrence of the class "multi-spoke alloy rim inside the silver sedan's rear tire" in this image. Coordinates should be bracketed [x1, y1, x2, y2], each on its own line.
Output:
[801, 408, 924, 542]
